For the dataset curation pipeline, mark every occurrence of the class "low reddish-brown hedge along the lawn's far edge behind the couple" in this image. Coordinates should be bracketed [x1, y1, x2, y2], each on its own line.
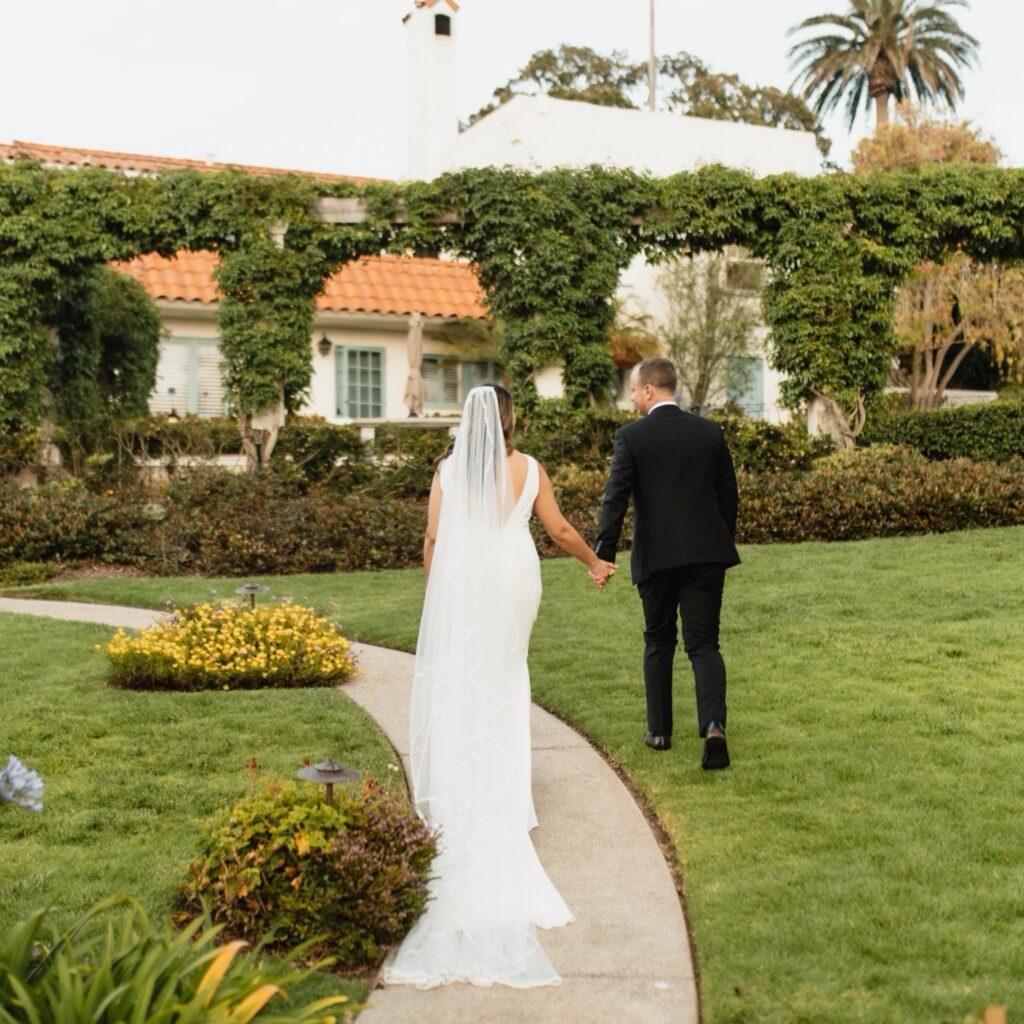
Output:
[0, 445, 1024, 575]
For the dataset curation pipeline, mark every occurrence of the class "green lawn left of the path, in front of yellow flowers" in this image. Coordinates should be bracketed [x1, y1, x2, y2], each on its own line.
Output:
[0, 614, 396, 998]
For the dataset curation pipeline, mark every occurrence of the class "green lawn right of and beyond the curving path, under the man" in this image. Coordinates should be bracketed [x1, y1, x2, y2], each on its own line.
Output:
[3, 528, 1024, 1024]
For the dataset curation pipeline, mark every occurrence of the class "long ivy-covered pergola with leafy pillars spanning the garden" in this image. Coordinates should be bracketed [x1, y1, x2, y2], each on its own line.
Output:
[0, 160, 1024, 460]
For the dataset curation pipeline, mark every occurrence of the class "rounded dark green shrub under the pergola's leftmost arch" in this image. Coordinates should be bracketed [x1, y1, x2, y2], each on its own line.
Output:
[49, 266, 161, 421]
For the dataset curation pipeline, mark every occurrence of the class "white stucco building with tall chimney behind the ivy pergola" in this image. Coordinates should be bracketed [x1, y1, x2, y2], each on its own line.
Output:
[404, 0, 820, 419]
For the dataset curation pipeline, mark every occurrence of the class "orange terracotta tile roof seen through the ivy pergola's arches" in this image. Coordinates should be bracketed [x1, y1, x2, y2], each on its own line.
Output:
[114, 252, 488, 319]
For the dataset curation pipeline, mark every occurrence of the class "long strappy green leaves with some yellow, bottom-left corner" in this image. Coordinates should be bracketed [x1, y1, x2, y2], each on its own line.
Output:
[0, 898, 357, 1024]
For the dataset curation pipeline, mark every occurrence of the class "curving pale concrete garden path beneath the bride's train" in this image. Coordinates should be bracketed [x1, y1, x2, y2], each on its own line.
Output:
[0, 598, 698, 1024]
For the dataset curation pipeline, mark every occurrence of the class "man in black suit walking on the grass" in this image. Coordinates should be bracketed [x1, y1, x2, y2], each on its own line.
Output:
[594, 358, 739, 769]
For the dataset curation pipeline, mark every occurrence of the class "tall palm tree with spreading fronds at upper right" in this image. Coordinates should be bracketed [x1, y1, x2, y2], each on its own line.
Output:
[788, 0, 978, 128]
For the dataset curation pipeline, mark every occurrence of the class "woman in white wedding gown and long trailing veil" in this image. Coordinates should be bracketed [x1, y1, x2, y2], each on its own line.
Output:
[383, 385, 614, 988]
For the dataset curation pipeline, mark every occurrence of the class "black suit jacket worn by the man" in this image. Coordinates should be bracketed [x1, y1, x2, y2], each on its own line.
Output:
[594, 406, 739, 583]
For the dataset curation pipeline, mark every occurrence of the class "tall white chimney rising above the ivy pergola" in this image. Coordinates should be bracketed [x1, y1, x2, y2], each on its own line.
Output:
[402, 0, 459, 181]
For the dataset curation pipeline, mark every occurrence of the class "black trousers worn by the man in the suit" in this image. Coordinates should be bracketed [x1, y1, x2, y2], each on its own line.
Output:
[637, 563, 726, 736]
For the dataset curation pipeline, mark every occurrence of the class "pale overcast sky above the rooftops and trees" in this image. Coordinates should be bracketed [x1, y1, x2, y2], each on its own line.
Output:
[0, 0, 1024, 178]
